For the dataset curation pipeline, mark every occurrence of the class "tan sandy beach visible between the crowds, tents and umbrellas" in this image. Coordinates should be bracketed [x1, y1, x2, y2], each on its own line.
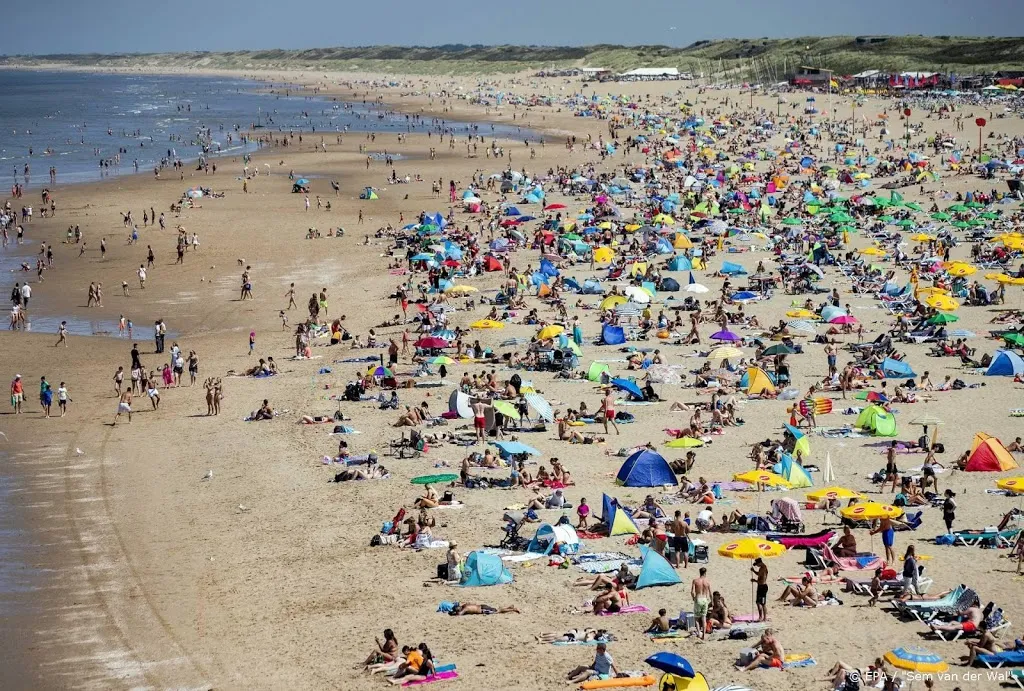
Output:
[0, 74, 1024, 691]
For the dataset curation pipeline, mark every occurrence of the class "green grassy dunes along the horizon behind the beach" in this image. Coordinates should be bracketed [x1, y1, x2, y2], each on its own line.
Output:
[6, 36, 1024, 76]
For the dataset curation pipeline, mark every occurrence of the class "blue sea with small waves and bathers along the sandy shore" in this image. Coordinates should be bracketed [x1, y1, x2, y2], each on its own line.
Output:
[0, 70, 537, 188]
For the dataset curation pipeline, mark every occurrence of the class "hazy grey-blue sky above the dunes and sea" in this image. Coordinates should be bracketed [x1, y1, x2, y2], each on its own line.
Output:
[0, 0, 1024, 54]
